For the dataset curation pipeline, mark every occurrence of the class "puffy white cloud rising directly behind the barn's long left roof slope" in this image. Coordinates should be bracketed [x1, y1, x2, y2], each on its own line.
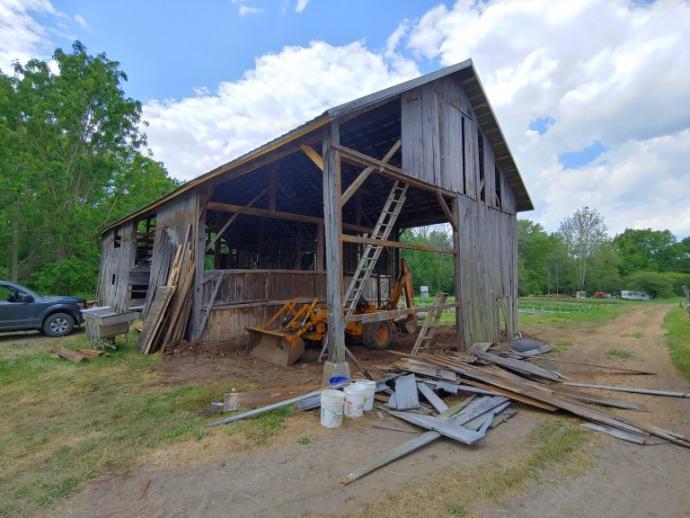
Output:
[144, 42, 419, 185]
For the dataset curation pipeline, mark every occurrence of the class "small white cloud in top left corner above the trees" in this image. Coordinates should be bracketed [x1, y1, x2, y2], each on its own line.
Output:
[0, 0, 57, 73]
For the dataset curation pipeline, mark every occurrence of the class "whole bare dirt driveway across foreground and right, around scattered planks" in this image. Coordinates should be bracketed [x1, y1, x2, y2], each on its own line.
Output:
[42, 306, 690, 517]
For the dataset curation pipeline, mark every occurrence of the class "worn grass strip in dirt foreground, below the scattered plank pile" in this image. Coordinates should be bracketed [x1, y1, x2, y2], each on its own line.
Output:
[359, 417, 591, 517]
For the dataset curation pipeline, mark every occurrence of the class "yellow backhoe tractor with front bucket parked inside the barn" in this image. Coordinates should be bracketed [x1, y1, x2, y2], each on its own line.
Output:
[247, 259, 417, 366]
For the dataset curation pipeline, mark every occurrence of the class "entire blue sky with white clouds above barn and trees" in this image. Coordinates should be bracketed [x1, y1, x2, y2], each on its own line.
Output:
[0, 0, 690, 236]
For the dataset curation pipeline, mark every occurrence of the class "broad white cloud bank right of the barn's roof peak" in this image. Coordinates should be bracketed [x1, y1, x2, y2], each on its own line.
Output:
[407, 0, 690, 239]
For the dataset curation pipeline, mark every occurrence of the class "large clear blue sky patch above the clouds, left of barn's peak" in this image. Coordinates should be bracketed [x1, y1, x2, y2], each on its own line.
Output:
[49, 0, 438, 101]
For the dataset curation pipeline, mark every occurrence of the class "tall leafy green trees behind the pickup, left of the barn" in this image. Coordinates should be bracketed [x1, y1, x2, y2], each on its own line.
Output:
[0, 42, 178, 294]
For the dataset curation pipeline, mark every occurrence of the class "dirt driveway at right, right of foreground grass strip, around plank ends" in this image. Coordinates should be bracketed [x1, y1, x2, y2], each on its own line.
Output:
[478, 306, 690, 518]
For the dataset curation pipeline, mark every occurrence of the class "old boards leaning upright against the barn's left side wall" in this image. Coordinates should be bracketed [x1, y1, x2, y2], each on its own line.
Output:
[139, 225, 196, 354]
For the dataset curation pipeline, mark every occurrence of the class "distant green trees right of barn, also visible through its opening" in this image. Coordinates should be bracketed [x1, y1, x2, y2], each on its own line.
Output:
[401, 207, 690, 297]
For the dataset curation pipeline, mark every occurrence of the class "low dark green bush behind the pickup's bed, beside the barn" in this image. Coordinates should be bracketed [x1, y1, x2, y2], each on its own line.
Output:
[33, 258, 98, 295]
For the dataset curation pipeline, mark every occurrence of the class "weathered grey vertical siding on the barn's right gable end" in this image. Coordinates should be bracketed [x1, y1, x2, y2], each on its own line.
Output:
[401, 71, 517, 345]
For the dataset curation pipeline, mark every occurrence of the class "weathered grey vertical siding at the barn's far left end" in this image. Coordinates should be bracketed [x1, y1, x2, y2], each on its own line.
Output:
[97, 222, 137, 311]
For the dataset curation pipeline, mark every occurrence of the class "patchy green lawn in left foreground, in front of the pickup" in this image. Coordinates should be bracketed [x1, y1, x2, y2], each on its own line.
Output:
[0, 334, 222, 516]
